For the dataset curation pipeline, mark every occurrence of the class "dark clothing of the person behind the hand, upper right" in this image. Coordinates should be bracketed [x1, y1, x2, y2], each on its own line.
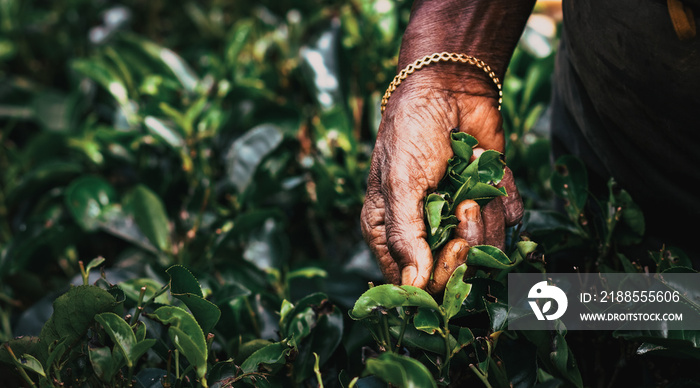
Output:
[552, 0, 700, 253]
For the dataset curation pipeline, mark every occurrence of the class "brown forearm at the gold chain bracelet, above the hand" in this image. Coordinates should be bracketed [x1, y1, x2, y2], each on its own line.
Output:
[399, 0, 535, 91]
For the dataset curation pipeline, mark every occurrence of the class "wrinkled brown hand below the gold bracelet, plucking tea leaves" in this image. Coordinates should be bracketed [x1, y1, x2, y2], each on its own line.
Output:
[361, 74, 522, 293]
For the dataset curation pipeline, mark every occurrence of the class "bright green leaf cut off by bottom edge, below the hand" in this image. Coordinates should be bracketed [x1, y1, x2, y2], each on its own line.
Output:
[364, 352, 437, 388]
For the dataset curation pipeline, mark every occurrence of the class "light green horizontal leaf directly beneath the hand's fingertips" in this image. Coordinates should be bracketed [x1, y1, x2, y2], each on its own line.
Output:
[350, 284, 438, 320]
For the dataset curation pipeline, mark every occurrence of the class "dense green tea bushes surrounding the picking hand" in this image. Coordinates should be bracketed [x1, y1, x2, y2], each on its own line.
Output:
[0, 0, 699, 387]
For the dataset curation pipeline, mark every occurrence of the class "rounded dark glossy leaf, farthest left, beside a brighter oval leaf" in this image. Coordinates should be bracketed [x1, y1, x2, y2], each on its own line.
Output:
[64, 175, 118, 232]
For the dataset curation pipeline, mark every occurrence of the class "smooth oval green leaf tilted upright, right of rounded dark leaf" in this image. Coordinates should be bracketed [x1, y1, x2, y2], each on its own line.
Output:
[126, 184, 171, 252]
